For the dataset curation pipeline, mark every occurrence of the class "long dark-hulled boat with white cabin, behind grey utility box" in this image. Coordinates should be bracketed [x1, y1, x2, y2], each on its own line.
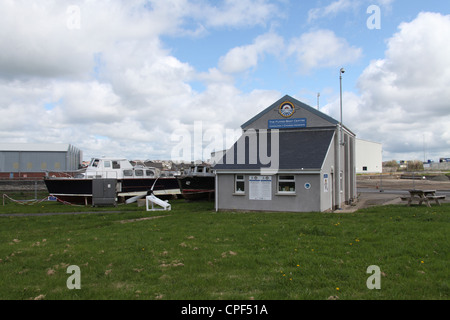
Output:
[44, 157, 181, 205]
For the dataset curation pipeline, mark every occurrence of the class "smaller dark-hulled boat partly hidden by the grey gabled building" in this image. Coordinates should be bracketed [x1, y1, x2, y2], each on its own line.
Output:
[177, 165, 216, 200]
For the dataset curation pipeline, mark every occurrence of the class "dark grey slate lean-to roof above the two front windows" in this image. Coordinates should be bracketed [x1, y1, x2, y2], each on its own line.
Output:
[214, 130, 335, 170]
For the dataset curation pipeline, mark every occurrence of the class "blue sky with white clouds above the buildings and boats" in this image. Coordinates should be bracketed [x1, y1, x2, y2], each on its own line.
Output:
[0, 0, 450, 161]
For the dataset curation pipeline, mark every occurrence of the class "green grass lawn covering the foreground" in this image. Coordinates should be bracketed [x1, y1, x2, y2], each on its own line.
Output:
[0, 192, 450, 300]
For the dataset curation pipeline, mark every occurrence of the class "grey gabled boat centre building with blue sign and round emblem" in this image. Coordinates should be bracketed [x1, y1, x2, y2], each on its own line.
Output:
[214, 96, 357, 212]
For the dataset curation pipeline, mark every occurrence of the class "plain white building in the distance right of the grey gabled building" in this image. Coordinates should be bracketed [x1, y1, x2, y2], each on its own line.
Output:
[356, 139, 383, 173]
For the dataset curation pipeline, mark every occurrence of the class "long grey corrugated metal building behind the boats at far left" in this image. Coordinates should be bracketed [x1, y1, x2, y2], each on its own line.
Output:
[0, 143, 82, 178]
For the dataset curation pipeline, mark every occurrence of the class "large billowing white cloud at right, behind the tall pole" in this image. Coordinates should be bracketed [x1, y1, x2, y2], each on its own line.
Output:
[323, 13, 450, 160]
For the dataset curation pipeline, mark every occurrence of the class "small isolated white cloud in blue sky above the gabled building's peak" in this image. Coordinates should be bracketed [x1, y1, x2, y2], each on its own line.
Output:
[288, 30, 362, 72]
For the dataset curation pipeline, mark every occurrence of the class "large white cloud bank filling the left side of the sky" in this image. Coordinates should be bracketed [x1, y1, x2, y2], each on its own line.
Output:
[0, 0, 282, 158]
